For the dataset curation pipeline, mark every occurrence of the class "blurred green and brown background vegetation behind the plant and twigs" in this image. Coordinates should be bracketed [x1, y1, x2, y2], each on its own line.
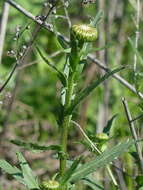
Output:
[0, 0, 143, 190]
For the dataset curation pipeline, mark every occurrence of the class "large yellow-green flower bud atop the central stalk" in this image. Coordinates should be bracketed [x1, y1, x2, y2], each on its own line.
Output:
[71, 24, 97, 42]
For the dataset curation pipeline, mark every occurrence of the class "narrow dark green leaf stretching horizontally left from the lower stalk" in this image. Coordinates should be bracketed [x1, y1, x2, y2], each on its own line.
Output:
[10, 140, 61, 152]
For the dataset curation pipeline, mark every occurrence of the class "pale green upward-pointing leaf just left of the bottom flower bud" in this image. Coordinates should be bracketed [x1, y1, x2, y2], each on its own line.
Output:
[17, 152, 39, 189]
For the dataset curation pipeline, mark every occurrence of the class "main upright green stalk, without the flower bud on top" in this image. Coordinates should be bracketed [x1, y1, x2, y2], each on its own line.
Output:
[60, 30, 80, 176]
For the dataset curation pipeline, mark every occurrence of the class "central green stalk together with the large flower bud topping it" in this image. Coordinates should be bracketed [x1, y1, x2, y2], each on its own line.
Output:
[60, 24, 97, 190]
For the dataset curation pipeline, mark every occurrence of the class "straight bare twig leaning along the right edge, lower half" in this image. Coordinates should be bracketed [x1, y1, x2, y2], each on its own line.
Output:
[122, 98, 143, 172]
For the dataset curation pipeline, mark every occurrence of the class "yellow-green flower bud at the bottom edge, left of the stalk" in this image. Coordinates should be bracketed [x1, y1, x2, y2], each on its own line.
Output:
[41, 180, 60, 190]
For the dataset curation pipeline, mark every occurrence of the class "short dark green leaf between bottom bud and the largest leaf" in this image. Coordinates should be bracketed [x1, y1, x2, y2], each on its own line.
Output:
[60, 157, 82, 185]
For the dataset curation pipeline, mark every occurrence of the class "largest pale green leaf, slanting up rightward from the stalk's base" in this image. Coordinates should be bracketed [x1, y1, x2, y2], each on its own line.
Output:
[70, 140, 135, 182]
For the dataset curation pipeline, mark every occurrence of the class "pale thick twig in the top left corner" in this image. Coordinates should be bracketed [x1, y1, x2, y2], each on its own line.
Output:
[0, 2, 9, 63]
